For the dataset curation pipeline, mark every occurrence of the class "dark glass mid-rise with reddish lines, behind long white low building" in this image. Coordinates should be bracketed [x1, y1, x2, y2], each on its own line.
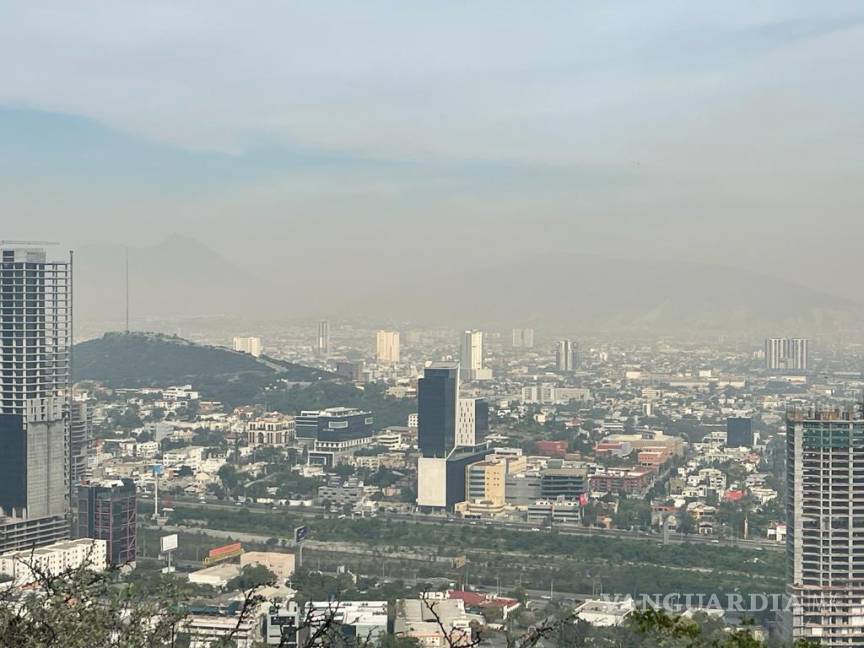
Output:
[76, 479, 138, 567]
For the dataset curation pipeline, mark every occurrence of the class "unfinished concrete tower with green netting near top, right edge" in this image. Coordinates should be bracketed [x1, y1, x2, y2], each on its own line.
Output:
[786, 406, 864, 648]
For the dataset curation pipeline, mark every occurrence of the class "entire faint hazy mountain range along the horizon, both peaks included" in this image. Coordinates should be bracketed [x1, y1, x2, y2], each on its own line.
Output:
[76, 236, 864, 336]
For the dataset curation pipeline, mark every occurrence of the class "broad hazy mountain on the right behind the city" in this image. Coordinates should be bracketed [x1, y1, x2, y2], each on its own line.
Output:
[364, 254, 864, 334]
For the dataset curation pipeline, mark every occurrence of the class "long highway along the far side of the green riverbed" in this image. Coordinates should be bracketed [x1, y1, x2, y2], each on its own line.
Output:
[141, 497, 785, 551]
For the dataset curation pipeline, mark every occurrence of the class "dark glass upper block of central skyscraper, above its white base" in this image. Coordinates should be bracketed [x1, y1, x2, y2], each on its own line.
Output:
[417, 362, 459, 458]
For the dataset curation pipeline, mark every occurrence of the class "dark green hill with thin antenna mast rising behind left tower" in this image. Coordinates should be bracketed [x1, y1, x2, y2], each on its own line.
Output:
[73, 333, 334, 387]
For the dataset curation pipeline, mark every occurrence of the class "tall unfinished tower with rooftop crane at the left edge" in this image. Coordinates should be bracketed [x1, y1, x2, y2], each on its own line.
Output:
[0, 244, 72, 546]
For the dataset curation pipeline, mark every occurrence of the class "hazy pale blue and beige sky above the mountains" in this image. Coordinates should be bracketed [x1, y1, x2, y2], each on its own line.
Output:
[0, 0, 864, 292]
